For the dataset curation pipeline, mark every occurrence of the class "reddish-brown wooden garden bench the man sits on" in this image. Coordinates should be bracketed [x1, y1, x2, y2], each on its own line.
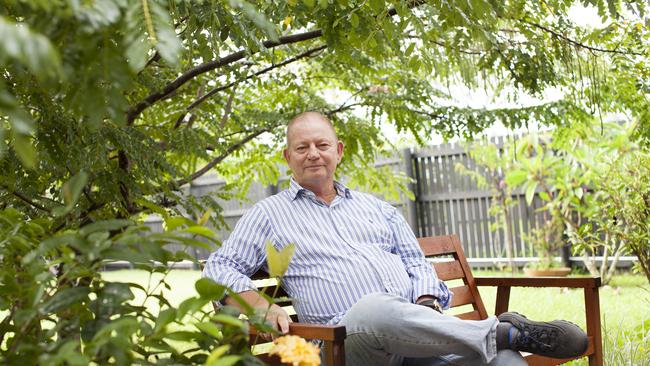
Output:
[240, 235, 603, 366]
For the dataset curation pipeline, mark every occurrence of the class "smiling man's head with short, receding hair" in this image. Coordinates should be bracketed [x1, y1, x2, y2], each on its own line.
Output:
[284, 112, 343, 194]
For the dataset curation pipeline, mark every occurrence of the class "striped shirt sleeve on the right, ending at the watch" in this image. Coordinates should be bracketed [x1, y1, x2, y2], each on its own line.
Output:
[382, 202, 453, 309]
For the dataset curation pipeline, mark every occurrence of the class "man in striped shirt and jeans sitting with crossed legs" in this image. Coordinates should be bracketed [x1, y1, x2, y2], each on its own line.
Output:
[204, 112, 587, 365]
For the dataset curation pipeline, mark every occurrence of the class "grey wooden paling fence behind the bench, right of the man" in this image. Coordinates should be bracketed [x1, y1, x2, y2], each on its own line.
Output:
[405, 138, 543, 264]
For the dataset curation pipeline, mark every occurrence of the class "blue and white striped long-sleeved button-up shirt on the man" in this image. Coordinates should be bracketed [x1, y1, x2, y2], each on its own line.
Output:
[203, 179, 451, 324]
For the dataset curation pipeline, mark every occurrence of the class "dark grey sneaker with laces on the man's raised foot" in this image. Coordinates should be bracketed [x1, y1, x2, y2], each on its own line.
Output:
[498, 312, 589, 358]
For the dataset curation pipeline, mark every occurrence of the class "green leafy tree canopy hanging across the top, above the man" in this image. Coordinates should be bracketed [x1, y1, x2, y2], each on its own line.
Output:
[0, 0, 650, 228]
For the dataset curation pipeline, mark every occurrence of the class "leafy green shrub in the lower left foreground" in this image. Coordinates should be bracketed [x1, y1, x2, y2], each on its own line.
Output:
[0, 209, 264, 365]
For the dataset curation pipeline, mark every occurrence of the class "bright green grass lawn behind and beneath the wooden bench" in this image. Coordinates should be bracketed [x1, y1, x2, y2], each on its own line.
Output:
[103, 270, 650, 365]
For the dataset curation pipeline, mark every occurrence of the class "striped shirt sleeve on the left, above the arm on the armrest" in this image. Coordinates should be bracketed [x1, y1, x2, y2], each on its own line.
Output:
[202, 205, 272, 293]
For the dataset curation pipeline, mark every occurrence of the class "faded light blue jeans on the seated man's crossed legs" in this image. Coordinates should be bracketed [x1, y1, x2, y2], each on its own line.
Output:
[339, 293, 526, 366]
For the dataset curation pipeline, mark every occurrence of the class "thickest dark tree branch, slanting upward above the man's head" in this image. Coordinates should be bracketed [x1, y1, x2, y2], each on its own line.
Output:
[126, 29, 323, 126]
